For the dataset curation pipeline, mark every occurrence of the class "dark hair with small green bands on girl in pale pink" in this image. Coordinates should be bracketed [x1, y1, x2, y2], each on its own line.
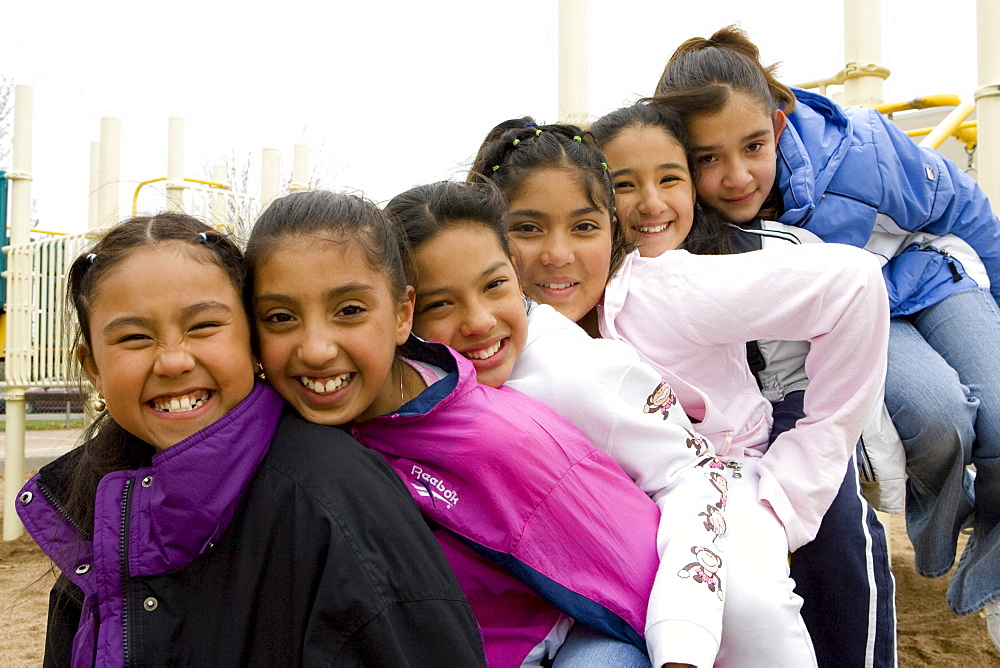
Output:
[469, 116, 635, 280]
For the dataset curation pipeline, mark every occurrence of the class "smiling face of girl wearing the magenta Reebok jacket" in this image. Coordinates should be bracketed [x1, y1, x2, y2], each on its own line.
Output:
[253, 237, 413, 425]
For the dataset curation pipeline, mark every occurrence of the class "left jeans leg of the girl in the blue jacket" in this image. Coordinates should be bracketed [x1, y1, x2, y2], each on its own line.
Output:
[885, 316, 979, 577]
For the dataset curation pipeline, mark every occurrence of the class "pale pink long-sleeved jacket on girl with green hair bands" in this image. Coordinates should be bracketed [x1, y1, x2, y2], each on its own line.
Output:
[600, 244, 889, 550]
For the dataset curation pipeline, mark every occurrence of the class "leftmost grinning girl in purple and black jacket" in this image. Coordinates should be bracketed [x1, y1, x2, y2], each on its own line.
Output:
[17, 214, 485, 666]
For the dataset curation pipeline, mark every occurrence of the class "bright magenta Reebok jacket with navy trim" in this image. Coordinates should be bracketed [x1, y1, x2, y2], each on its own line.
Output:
[351, 338, 659, 666]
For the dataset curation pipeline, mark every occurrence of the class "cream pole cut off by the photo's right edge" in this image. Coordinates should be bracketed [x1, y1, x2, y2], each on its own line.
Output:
[976, 0, 1000, 204]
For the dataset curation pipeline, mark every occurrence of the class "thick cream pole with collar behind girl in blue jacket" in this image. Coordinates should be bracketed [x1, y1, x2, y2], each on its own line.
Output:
[844, 0, 888, 106]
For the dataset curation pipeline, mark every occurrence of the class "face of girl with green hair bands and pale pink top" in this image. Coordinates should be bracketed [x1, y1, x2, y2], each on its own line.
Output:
[508, 169, 612, 322]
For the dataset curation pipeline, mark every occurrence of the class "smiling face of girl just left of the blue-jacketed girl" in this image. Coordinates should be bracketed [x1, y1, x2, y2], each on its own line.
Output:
[603, 126, 695, 257]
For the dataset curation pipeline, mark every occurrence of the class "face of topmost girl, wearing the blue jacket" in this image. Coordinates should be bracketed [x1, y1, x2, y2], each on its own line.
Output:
[689, 93, 785, 223]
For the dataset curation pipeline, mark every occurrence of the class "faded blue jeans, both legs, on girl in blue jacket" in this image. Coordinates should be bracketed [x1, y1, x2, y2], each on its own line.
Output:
[885, 288, 1000, 615]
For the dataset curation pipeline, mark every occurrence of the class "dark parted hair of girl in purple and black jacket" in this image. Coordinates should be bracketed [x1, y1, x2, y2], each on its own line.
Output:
[64, 213, 243, 536]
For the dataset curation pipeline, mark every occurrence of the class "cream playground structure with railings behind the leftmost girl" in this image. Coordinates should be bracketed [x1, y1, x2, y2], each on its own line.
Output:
[3, 94, 308, 540]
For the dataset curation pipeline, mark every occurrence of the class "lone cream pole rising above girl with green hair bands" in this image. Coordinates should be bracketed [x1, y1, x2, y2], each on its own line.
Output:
[558, 0, 590, 124]
